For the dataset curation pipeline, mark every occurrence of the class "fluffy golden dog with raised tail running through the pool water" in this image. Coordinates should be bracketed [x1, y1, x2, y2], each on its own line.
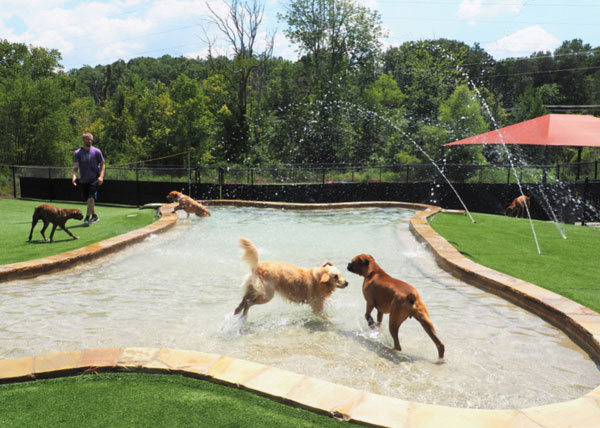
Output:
[234, 238, 348, 316]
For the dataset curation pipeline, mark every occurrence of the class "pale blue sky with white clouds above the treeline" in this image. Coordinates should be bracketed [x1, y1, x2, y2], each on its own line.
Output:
[0, 0, 600, 70]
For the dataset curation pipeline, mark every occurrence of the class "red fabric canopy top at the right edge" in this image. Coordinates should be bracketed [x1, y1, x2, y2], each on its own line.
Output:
[444, 114, 600, 147]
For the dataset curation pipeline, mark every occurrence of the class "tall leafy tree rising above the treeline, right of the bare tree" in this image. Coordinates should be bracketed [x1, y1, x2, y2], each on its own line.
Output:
[280, 0, 384, 162]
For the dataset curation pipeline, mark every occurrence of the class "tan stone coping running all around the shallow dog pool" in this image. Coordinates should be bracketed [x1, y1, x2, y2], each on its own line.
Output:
[0, 201, 600, 428]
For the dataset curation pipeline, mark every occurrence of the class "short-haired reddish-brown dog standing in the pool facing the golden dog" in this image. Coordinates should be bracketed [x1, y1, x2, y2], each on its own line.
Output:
[348, 254, 445, 359]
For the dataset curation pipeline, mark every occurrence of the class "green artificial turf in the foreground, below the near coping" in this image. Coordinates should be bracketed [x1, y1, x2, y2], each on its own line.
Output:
[0, 373, 348, 428]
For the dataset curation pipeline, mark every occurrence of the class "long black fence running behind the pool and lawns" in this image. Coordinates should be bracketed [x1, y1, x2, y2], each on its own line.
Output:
[5, 162, 600, 223]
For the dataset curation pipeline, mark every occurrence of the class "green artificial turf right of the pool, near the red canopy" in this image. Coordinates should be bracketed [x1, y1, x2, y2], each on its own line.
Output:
[430, 213, 600, 312]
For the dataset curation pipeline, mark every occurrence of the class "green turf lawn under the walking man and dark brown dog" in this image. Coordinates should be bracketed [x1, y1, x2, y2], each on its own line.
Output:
[0, 199, 156, 265]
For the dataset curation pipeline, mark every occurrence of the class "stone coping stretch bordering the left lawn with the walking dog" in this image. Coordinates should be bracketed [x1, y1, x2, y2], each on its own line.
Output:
[0, 203, 177, 282]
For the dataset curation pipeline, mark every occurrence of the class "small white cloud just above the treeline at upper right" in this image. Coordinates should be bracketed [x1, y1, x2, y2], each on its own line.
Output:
[485, 25, 561, 59]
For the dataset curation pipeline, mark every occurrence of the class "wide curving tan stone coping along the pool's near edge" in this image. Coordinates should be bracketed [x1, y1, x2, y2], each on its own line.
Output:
[0, 347, 600, 428]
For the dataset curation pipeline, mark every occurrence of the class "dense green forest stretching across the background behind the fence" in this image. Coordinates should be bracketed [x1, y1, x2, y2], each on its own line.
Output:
[0, 0, 600, 174]
